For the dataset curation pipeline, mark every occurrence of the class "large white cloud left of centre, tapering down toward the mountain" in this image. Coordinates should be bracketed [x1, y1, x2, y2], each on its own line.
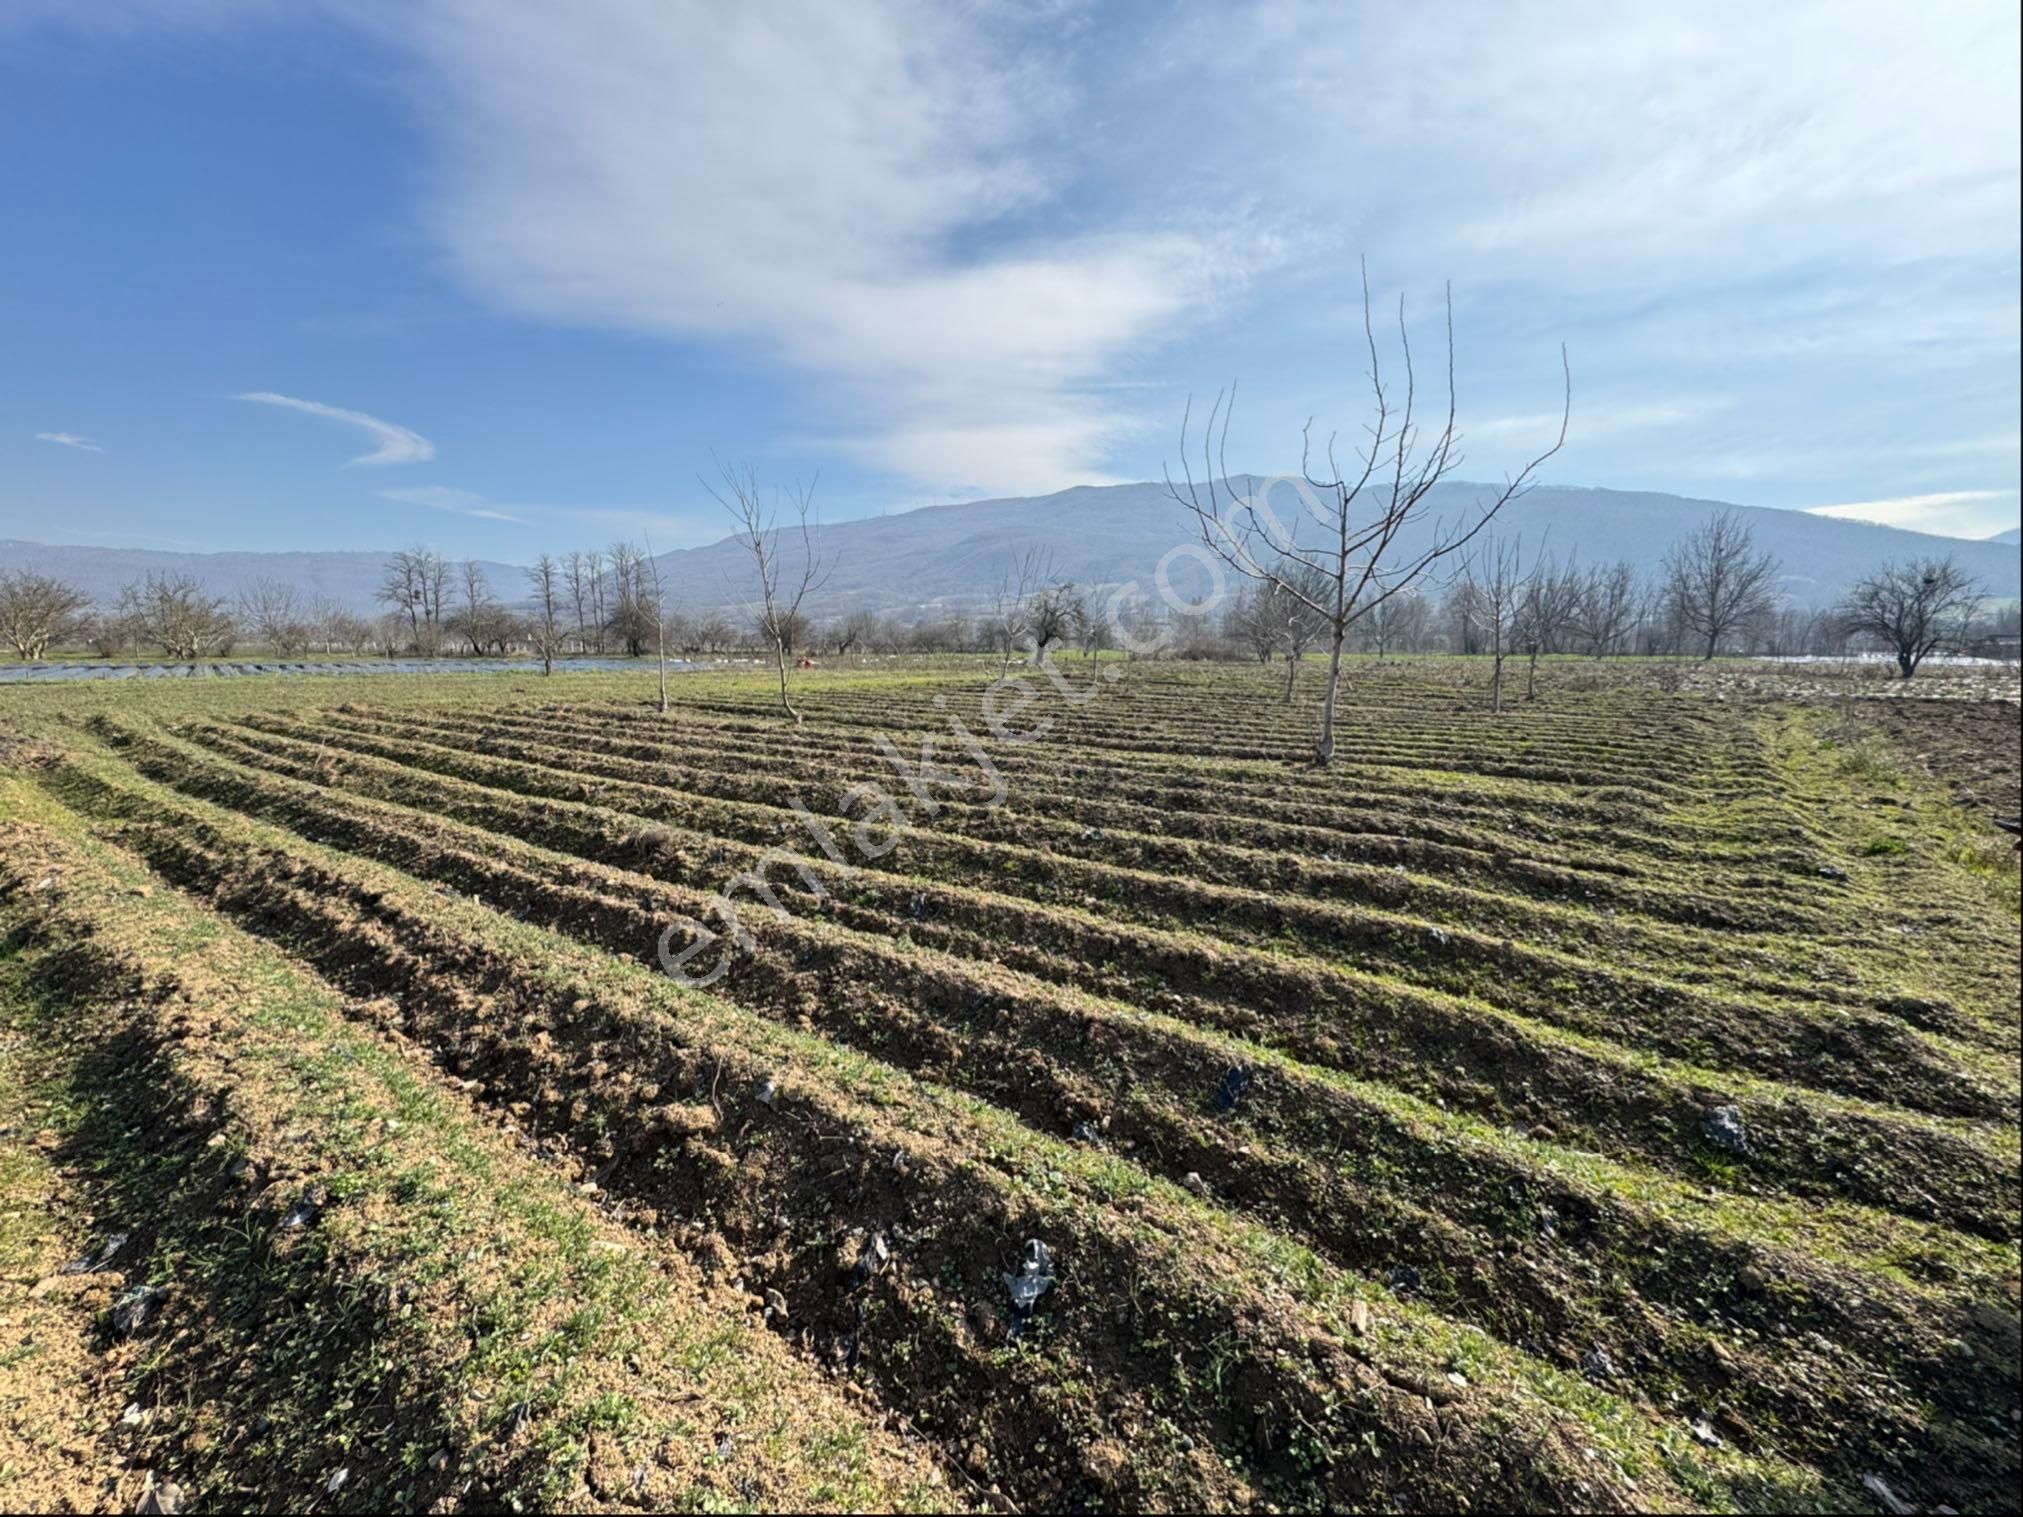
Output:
[354, 0, 1264, 487]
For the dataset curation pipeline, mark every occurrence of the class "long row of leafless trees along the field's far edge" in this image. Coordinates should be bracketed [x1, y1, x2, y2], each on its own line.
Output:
[0, 511, 2019, 683]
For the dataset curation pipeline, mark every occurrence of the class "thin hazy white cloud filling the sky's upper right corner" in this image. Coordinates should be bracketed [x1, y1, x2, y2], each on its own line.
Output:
[1179, 0, 2019, 287]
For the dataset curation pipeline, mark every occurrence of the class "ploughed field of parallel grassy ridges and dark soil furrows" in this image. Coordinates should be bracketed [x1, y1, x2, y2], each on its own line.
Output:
[0, 661, 2023, 1511]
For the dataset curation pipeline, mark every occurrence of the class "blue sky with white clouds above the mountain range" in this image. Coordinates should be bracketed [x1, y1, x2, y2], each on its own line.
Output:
[0, 0, 2023, 562]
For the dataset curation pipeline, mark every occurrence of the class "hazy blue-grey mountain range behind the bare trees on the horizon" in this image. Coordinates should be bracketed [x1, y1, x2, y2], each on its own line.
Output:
[0, 477, 2023, 619]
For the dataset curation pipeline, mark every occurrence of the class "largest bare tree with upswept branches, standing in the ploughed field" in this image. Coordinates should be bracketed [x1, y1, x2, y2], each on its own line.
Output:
[1167, 269, 1574, 767]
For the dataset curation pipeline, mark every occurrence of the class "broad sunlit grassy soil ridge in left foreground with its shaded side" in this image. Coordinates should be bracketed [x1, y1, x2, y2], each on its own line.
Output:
[0, 779, 953, 1511]
